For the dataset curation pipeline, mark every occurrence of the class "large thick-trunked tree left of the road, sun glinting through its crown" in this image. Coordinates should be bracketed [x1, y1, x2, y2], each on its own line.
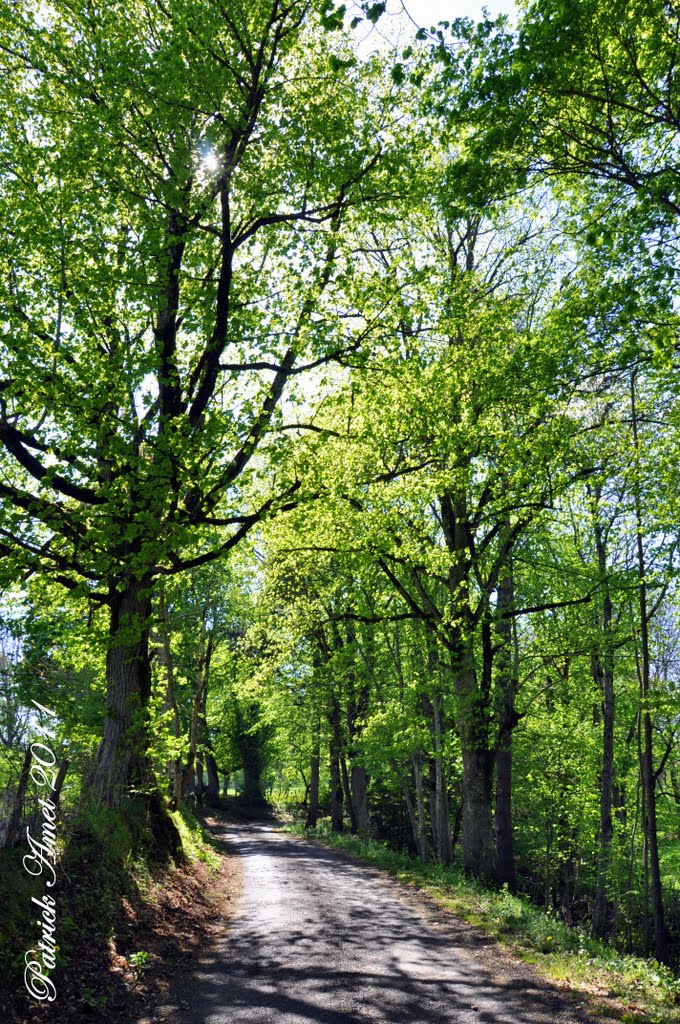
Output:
[0, 0, 393, 835]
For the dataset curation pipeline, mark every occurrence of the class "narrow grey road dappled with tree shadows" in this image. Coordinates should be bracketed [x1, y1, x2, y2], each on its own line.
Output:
[174, 824, 589, 1024]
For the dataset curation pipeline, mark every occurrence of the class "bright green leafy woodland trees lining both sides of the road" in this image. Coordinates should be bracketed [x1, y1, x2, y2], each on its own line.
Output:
[0, 0, 680, 1019]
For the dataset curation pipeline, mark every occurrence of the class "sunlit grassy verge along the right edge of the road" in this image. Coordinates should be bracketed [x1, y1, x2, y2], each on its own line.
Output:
[285, 823, 680, 1024]
